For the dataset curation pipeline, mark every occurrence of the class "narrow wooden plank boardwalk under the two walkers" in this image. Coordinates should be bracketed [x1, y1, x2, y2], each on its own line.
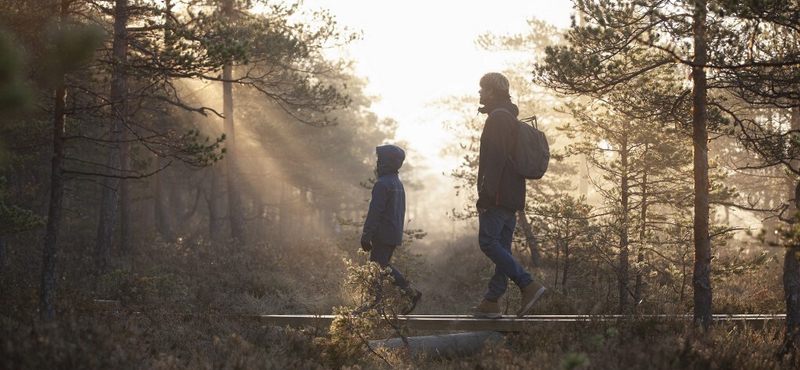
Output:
[256, 314, 786, 332]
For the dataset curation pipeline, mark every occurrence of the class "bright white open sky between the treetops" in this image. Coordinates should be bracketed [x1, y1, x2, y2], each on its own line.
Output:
[305, 0, 572, 168]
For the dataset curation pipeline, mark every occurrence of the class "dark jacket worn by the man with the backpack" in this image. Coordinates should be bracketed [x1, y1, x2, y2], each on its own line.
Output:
[477, 97, 525, 212]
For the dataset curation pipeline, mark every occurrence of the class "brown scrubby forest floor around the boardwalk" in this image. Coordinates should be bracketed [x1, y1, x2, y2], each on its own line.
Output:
[0, 234, 795, 369]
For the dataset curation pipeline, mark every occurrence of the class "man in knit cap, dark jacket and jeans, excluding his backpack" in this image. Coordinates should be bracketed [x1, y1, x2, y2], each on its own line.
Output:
[473, 72, 545, 318]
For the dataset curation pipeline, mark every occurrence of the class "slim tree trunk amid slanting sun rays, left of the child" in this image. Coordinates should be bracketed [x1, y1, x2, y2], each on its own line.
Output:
[222, 0, 247, 245]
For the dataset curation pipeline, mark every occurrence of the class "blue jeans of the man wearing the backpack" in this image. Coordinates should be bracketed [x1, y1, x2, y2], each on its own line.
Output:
[478, 206, 533, 301]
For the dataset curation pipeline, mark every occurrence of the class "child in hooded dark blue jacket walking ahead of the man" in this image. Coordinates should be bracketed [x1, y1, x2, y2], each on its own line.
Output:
[361, 145, 422, 315]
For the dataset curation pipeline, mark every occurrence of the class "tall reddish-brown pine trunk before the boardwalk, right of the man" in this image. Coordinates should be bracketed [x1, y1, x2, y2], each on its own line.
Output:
[692, 0, 712, 329]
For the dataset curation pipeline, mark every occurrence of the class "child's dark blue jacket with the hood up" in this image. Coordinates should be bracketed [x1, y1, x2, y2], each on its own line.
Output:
[361, 145, 406, 246]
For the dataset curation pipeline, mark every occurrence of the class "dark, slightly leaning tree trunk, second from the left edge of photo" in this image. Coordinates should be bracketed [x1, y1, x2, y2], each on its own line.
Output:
[95, 0, 128, 274]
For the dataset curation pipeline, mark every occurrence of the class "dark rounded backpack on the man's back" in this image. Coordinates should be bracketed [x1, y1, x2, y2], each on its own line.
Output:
[492, 108, 550, 179]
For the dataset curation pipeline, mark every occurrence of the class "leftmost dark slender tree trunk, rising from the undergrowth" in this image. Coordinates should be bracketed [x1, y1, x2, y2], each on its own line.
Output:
[39, 0, 70, 321]
